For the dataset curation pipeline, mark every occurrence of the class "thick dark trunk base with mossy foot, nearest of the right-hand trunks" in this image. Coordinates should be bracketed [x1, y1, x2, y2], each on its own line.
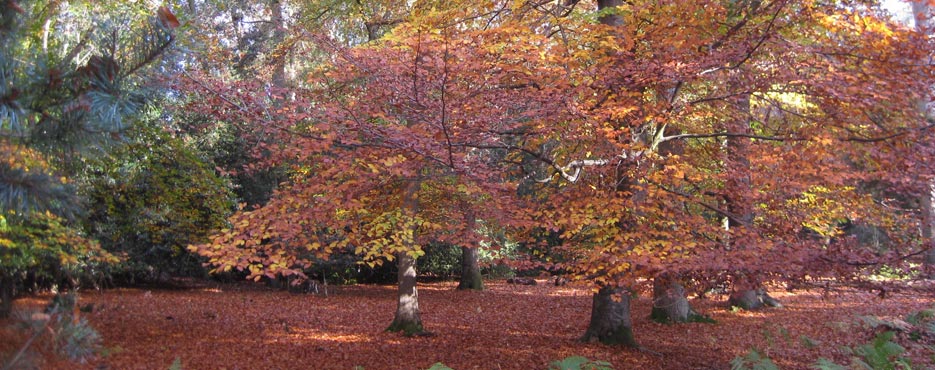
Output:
[581, 287, 637, 347]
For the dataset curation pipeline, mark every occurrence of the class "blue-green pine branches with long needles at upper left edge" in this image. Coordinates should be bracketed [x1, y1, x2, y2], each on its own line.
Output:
[0, 0, 179, 217]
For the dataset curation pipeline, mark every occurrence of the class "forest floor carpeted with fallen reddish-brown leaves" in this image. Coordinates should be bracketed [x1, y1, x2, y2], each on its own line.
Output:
[0, 280, 935, 370]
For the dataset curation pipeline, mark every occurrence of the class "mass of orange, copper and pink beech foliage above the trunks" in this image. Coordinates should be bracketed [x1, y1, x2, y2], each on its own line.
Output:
[186, 0, 933, 292]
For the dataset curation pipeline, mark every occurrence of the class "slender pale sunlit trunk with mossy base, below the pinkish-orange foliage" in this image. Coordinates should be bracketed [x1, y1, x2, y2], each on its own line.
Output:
[386, 252, 424, 335]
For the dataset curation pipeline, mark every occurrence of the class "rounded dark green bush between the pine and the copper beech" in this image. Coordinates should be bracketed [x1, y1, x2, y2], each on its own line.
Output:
[84, 123, 234, 281]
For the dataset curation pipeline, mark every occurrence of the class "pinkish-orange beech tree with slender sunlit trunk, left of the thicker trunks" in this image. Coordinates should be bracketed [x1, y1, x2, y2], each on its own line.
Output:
[194, 18, 554, 334]
